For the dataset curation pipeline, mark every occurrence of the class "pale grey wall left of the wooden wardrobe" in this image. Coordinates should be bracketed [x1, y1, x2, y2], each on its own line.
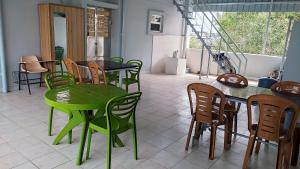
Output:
[2, 0, 60, 90]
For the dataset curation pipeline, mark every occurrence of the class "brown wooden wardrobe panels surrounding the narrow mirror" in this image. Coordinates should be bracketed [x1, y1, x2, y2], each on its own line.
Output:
[38, 4, 85, 71]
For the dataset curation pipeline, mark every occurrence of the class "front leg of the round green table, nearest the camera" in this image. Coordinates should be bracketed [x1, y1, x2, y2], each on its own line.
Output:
[76, 111, 90, 165]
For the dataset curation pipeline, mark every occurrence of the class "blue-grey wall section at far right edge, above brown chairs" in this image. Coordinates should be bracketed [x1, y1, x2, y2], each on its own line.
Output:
[283, 21, 300, 82]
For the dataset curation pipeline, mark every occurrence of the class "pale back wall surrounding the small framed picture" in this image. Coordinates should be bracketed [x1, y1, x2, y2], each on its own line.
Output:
[111, 0, 182, 71]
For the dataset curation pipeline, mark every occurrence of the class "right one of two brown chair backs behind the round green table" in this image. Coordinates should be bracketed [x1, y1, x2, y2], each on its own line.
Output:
[88, 61, 107, 85]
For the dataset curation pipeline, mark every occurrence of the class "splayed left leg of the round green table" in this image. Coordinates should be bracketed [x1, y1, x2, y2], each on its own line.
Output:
[53, 112, 82, 145]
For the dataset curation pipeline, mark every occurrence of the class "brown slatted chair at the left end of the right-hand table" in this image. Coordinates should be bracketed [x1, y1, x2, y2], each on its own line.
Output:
[185, 83, 228, 160]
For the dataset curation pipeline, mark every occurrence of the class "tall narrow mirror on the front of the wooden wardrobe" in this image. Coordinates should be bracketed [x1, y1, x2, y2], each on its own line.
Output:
[54, 16, 67, 56]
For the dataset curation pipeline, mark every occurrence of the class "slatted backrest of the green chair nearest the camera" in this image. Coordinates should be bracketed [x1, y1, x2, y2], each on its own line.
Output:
[106, 92, 142, 130]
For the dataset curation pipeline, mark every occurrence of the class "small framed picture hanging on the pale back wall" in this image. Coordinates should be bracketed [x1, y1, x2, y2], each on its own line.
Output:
[147, 9, 164, 34]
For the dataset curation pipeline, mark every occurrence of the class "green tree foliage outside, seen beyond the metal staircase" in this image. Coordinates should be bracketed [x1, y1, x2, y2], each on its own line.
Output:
[190, 12, 300, 56]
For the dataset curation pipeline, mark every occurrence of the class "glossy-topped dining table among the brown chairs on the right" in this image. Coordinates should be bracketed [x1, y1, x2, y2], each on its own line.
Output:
[207, 80, 300, 166]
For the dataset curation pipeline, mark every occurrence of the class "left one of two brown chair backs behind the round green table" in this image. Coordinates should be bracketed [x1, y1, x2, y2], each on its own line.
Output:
[63, 58, 91, 83]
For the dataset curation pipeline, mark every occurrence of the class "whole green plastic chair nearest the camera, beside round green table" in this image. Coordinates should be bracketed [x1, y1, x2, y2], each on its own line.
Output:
[86, 92, 142, 169]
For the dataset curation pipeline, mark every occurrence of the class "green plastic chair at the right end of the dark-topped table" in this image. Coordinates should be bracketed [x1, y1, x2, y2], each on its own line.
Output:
[123, 60, 143, 92]
